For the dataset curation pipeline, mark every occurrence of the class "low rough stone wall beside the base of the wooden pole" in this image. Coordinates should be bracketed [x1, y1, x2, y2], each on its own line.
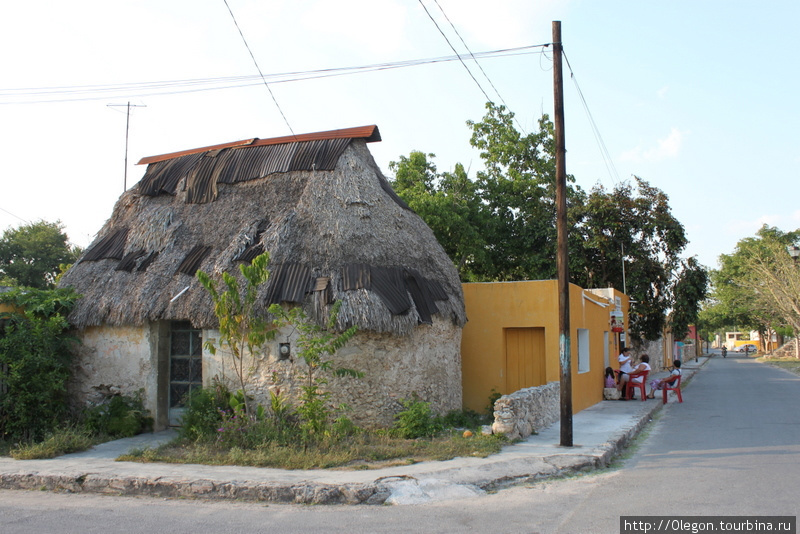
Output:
[492, 382, 561, 439]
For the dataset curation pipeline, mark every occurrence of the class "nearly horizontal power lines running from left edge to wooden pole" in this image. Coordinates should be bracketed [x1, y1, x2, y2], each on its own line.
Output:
[0, 44, 549, 105]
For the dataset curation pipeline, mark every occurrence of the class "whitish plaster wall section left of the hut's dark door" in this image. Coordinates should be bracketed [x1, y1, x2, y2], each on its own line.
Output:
[69, 326, 157, 414]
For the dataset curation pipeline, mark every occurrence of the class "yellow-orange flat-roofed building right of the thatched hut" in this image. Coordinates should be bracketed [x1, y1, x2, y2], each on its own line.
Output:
[461, 280, 628, 412]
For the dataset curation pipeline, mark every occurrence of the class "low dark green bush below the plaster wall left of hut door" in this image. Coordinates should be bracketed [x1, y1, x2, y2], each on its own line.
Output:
[83, 391, 153, 438]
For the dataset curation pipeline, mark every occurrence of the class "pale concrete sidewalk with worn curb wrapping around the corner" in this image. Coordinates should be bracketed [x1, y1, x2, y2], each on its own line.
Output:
[0, 357, 708, 504]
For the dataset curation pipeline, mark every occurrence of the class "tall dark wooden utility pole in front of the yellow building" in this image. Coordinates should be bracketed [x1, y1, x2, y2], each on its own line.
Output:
[553, 20, 572, 447]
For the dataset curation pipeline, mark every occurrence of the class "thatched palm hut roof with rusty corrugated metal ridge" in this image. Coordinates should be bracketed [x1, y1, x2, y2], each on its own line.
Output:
[61, 126, 466, 334]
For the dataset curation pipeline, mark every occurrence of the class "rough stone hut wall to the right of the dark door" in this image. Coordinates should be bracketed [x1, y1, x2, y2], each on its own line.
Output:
[203, 318, 462, 427]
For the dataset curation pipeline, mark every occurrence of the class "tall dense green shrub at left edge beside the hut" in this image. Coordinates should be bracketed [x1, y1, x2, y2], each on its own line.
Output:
[0, 289, 77, 441]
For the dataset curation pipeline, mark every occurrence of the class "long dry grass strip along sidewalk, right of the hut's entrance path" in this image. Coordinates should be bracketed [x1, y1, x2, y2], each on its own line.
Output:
[118, 431, 508, 470]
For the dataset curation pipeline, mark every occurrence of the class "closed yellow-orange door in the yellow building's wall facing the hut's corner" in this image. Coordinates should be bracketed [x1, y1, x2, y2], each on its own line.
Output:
[505, 328, 546, 394]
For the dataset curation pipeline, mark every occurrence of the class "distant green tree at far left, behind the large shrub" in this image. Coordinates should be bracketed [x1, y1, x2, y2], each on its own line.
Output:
[0, 221, 81, 289]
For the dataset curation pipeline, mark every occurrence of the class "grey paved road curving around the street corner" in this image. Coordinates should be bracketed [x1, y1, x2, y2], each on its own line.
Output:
[0, 353, 800, 533]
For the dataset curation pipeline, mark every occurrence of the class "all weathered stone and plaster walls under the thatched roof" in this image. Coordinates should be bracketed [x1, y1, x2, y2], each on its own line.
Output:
[69, 317, 462, 436]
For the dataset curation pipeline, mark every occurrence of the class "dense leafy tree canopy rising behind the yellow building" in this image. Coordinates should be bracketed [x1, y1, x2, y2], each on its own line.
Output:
[390, 103, 707, 339]
